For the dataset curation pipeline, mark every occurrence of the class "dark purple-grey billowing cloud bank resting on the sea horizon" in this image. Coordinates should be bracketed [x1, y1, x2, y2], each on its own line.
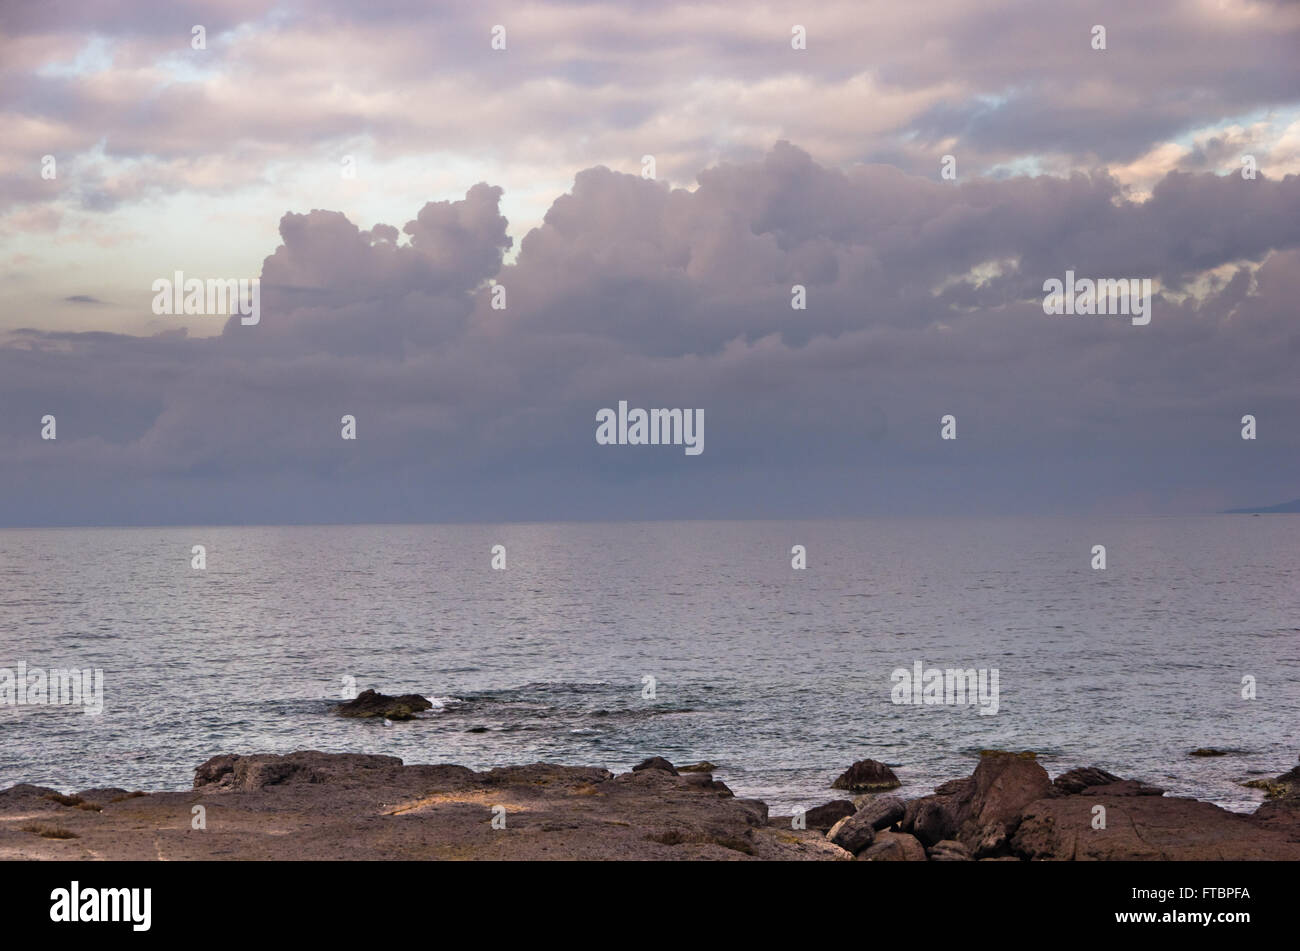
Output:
[0, 143, 1300, 525]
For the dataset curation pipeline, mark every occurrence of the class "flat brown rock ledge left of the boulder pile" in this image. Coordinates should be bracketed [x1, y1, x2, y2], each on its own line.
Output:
[0, 751, 850, 860]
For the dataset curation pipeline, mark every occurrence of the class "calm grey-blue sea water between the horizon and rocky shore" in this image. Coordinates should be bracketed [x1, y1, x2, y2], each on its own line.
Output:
[0, 516, 1300, 809]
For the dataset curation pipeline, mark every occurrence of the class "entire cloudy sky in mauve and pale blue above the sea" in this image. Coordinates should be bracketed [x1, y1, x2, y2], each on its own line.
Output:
[0, 0, 1300, 526]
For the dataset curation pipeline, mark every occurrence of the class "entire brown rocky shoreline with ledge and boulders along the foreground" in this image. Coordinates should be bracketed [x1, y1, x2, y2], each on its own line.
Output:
[0, 751, 1300, 861]
